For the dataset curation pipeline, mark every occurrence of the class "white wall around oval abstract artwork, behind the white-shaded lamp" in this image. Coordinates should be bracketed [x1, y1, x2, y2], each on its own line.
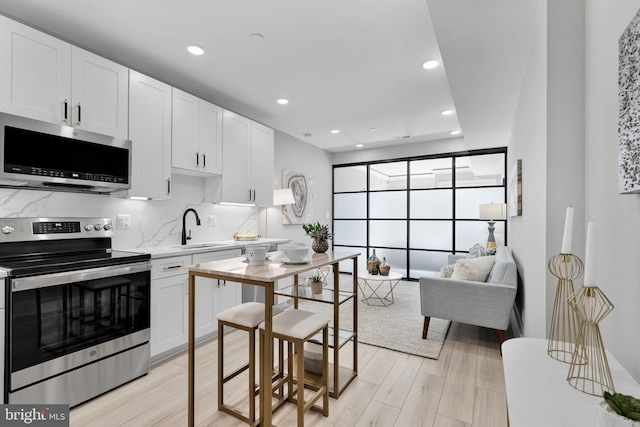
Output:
[258, 130, 333, 245]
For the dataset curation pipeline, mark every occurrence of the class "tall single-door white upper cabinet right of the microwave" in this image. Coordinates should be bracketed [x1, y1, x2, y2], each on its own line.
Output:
[114, 70, 171, 199]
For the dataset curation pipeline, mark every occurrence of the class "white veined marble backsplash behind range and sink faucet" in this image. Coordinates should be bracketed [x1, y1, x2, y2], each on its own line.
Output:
[0, 175, 258, 249]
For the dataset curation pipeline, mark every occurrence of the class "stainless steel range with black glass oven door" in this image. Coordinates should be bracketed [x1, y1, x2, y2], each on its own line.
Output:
[0, 218, 151, 406]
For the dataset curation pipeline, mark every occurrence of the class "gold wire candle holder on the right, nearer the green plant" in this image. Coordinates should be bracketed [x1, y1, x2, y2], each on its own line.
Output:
[567, 286, 615, 396]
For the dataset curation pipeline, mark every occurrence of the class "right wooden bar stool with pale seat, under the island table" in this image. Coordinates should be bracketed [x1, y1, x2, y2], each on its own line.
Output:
[259, 309, 329, 427]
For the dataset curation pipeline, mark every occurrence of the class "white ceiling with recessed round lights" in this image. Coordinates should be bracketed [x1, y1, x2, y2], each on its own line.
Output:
[0, 0, 545, 152]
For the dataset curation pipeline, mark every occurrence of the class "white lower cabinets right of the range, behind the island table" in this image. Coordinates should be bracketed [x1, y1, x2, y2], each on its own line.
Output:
[151, 249, 242, 359]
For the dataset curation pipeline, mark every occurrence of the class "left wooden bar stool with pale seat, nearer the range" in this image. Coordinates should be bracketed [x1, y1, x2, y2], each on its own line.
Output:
[216, 302, 288, 426]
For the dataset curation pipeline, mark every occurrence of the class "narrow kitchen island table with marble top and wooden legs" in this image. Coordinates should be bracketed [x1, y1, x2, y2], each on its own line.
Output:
[186, 251, 360, 427]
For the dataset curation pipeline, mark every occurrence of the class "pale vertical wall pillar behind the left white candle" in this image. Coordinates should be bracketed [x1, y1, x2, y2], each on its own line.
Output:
[545, 0, 586, 342]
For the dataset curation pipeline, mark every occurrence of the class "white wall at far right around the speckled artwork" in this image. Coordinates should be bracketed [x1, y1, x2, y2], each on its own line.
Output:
[585, 0, 640, 382]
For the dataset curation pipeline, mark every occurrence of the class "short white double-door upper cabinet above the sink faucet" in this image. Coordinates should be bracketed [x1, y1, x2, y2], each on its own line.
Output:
[171, 88, 222, 175]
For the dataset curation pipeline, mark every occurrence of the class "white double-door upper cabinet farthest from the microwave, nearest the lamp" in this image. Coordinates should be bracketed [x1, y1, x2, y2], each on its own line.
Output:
[221, 110, 274, 205]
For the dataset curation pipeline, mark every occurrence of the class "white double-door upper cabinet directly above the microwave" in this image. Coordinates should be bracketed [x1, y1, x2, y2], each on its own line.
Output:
[0, 16, 128, 138]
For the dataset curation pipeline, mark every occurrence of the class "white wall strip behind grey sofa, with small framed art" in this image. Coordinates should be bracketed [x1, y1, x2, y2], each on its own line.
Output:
[507, 4, 547, 337]
